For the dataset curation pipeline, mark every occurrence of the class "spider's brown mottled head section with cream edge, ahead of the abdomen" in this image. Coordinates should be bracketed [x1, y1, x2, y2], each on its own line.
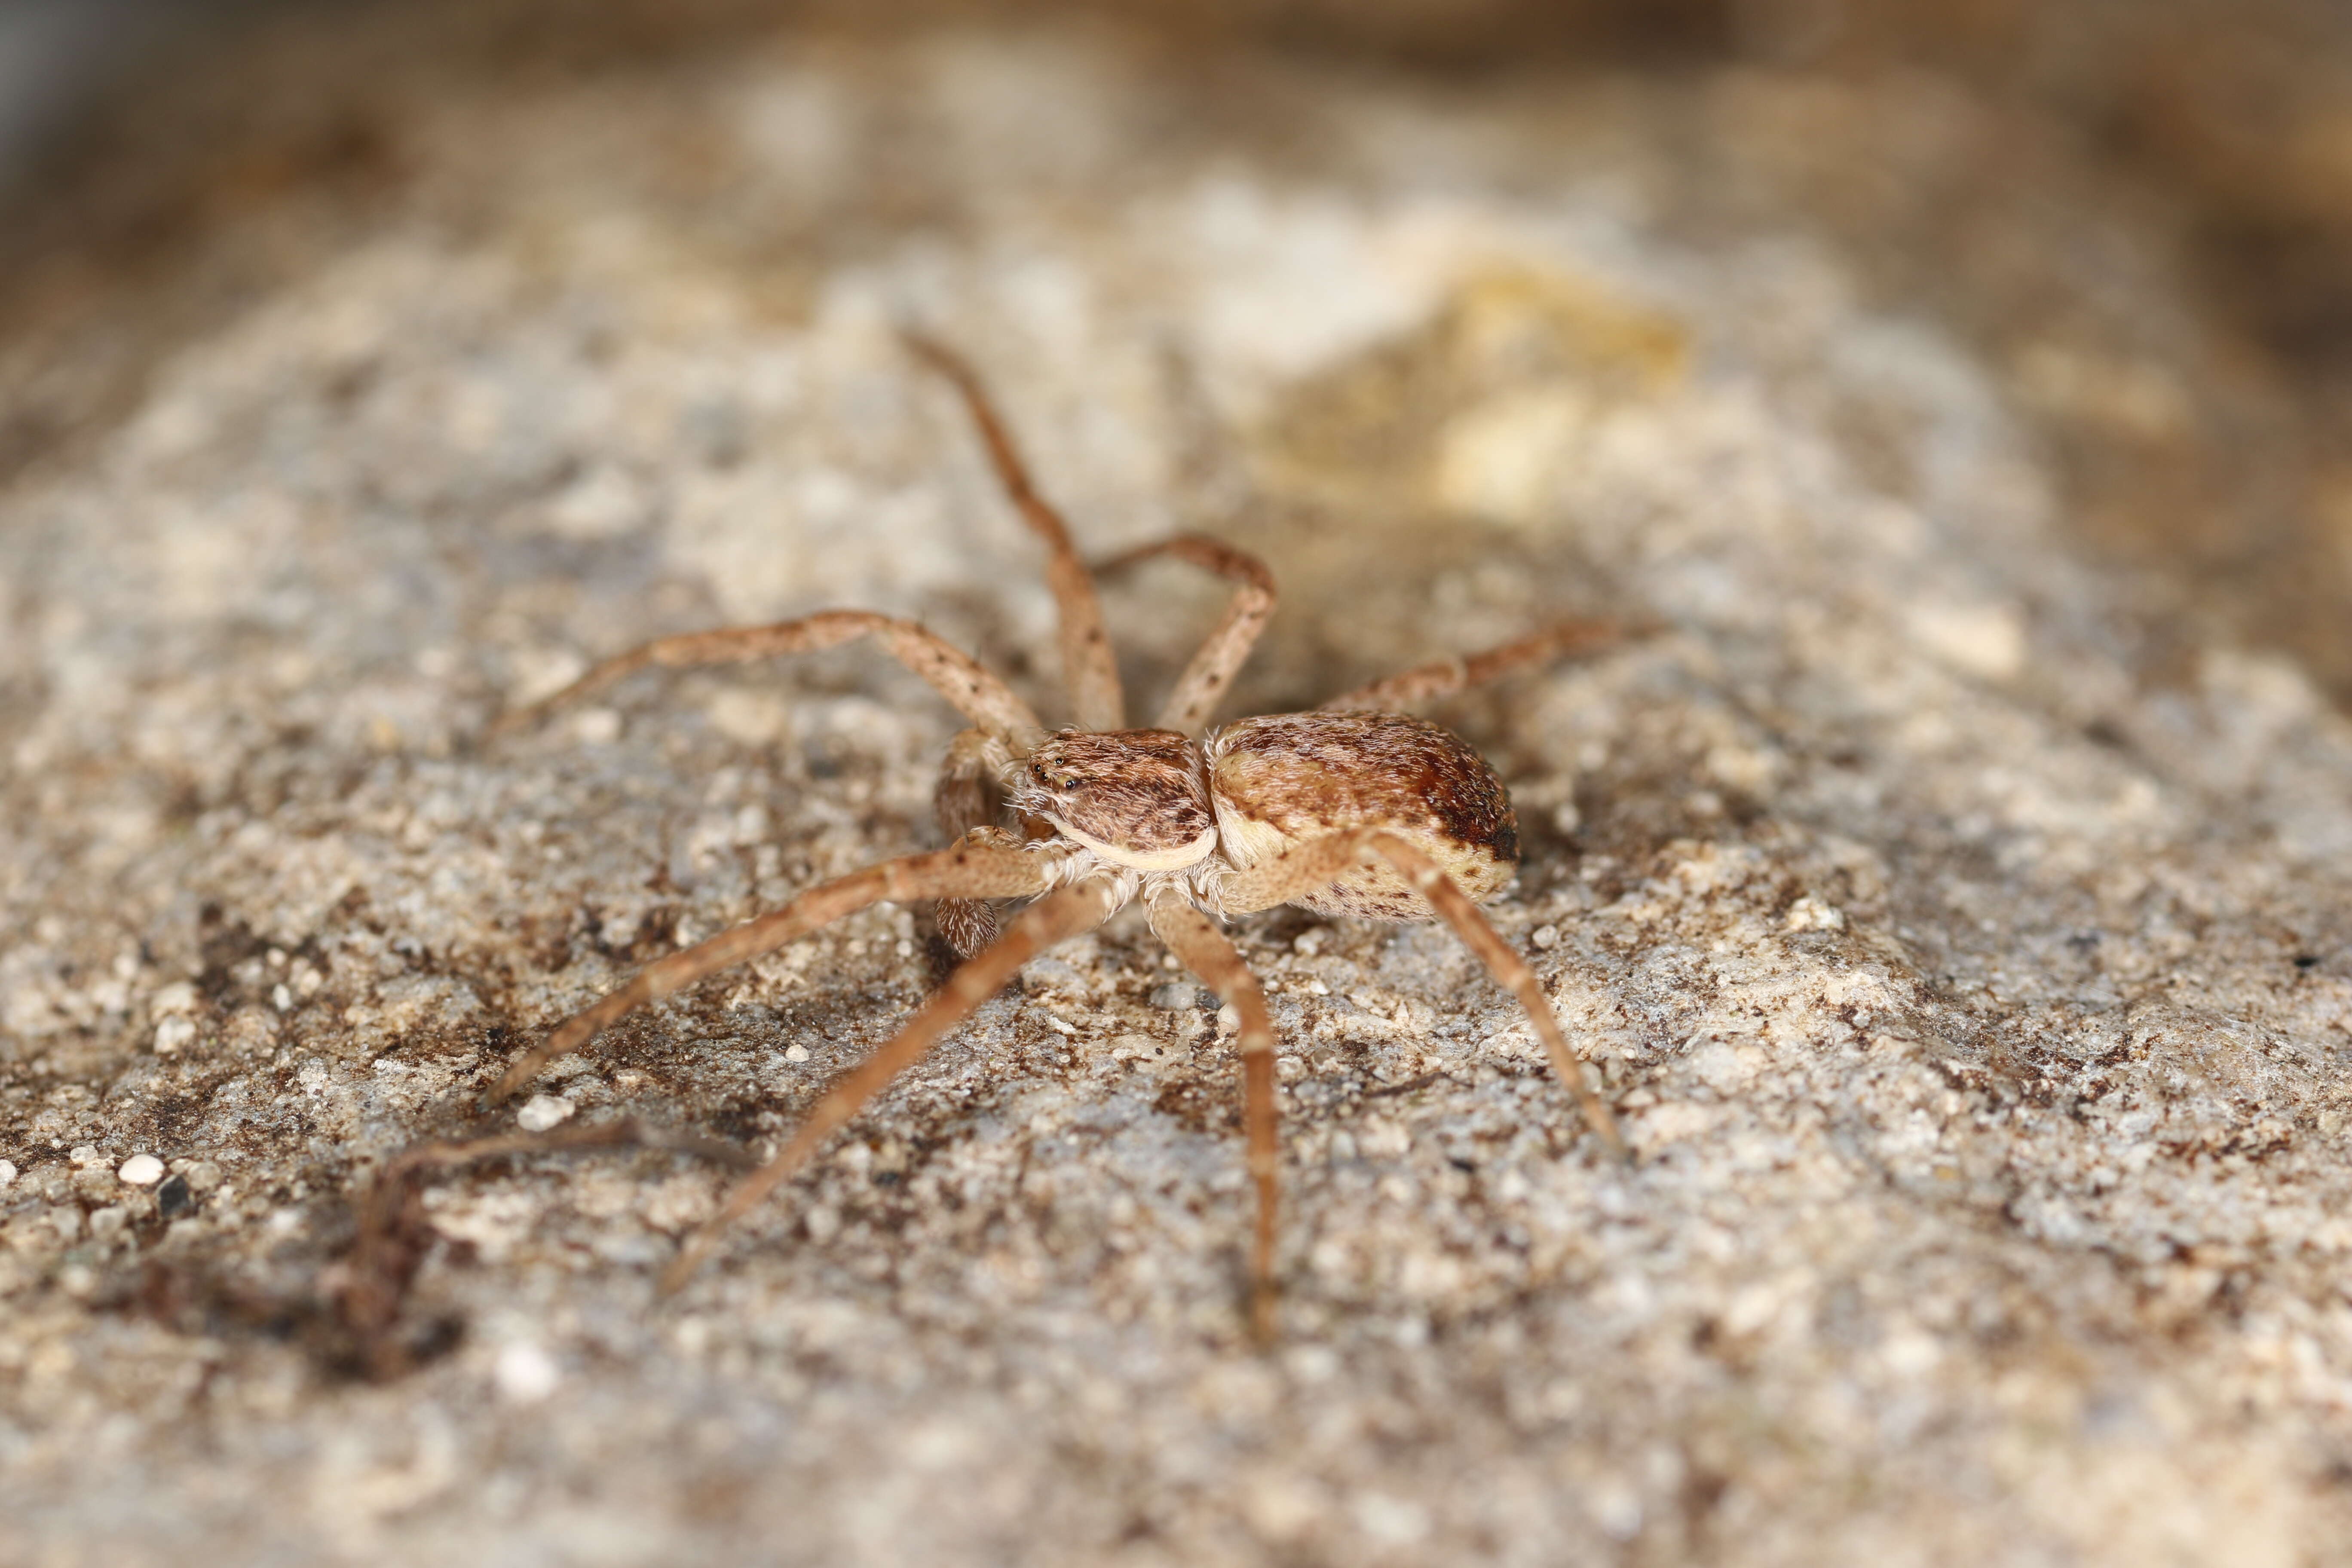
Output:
[1011, 729, 1216, 872]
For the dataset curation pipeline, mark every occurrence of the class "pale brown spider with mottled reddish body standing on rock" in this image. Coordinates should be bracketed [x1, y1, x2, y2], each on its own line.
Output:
[487, 334, 1628, 1340]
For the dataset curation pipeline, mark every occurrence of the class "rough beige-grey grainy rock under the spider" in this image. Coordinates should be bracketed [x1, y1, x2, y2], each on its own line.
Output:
[0, 15, 2352, 1563]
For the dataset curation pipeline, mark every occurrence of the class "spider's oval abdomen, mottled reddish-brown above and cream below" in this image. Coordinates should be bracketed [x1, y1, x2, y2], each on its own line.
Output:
[1202, 712, 1519, 919]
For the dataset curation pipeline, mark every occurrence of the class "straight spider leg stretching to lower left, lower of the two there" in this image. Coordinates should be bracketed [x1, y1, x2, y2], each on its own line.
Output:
[661, 879, 1120, 1295]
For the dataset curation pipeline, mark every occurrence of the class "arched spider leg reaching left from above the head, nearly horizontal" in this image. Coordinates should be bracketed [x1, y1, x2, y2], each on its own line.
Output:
[489, 609, 1040, 736]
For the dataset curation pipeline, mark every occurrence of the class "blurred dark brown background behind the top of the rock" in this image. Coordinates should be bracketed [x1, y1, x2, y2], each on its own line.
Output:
[0, 0, 2352, 703]
